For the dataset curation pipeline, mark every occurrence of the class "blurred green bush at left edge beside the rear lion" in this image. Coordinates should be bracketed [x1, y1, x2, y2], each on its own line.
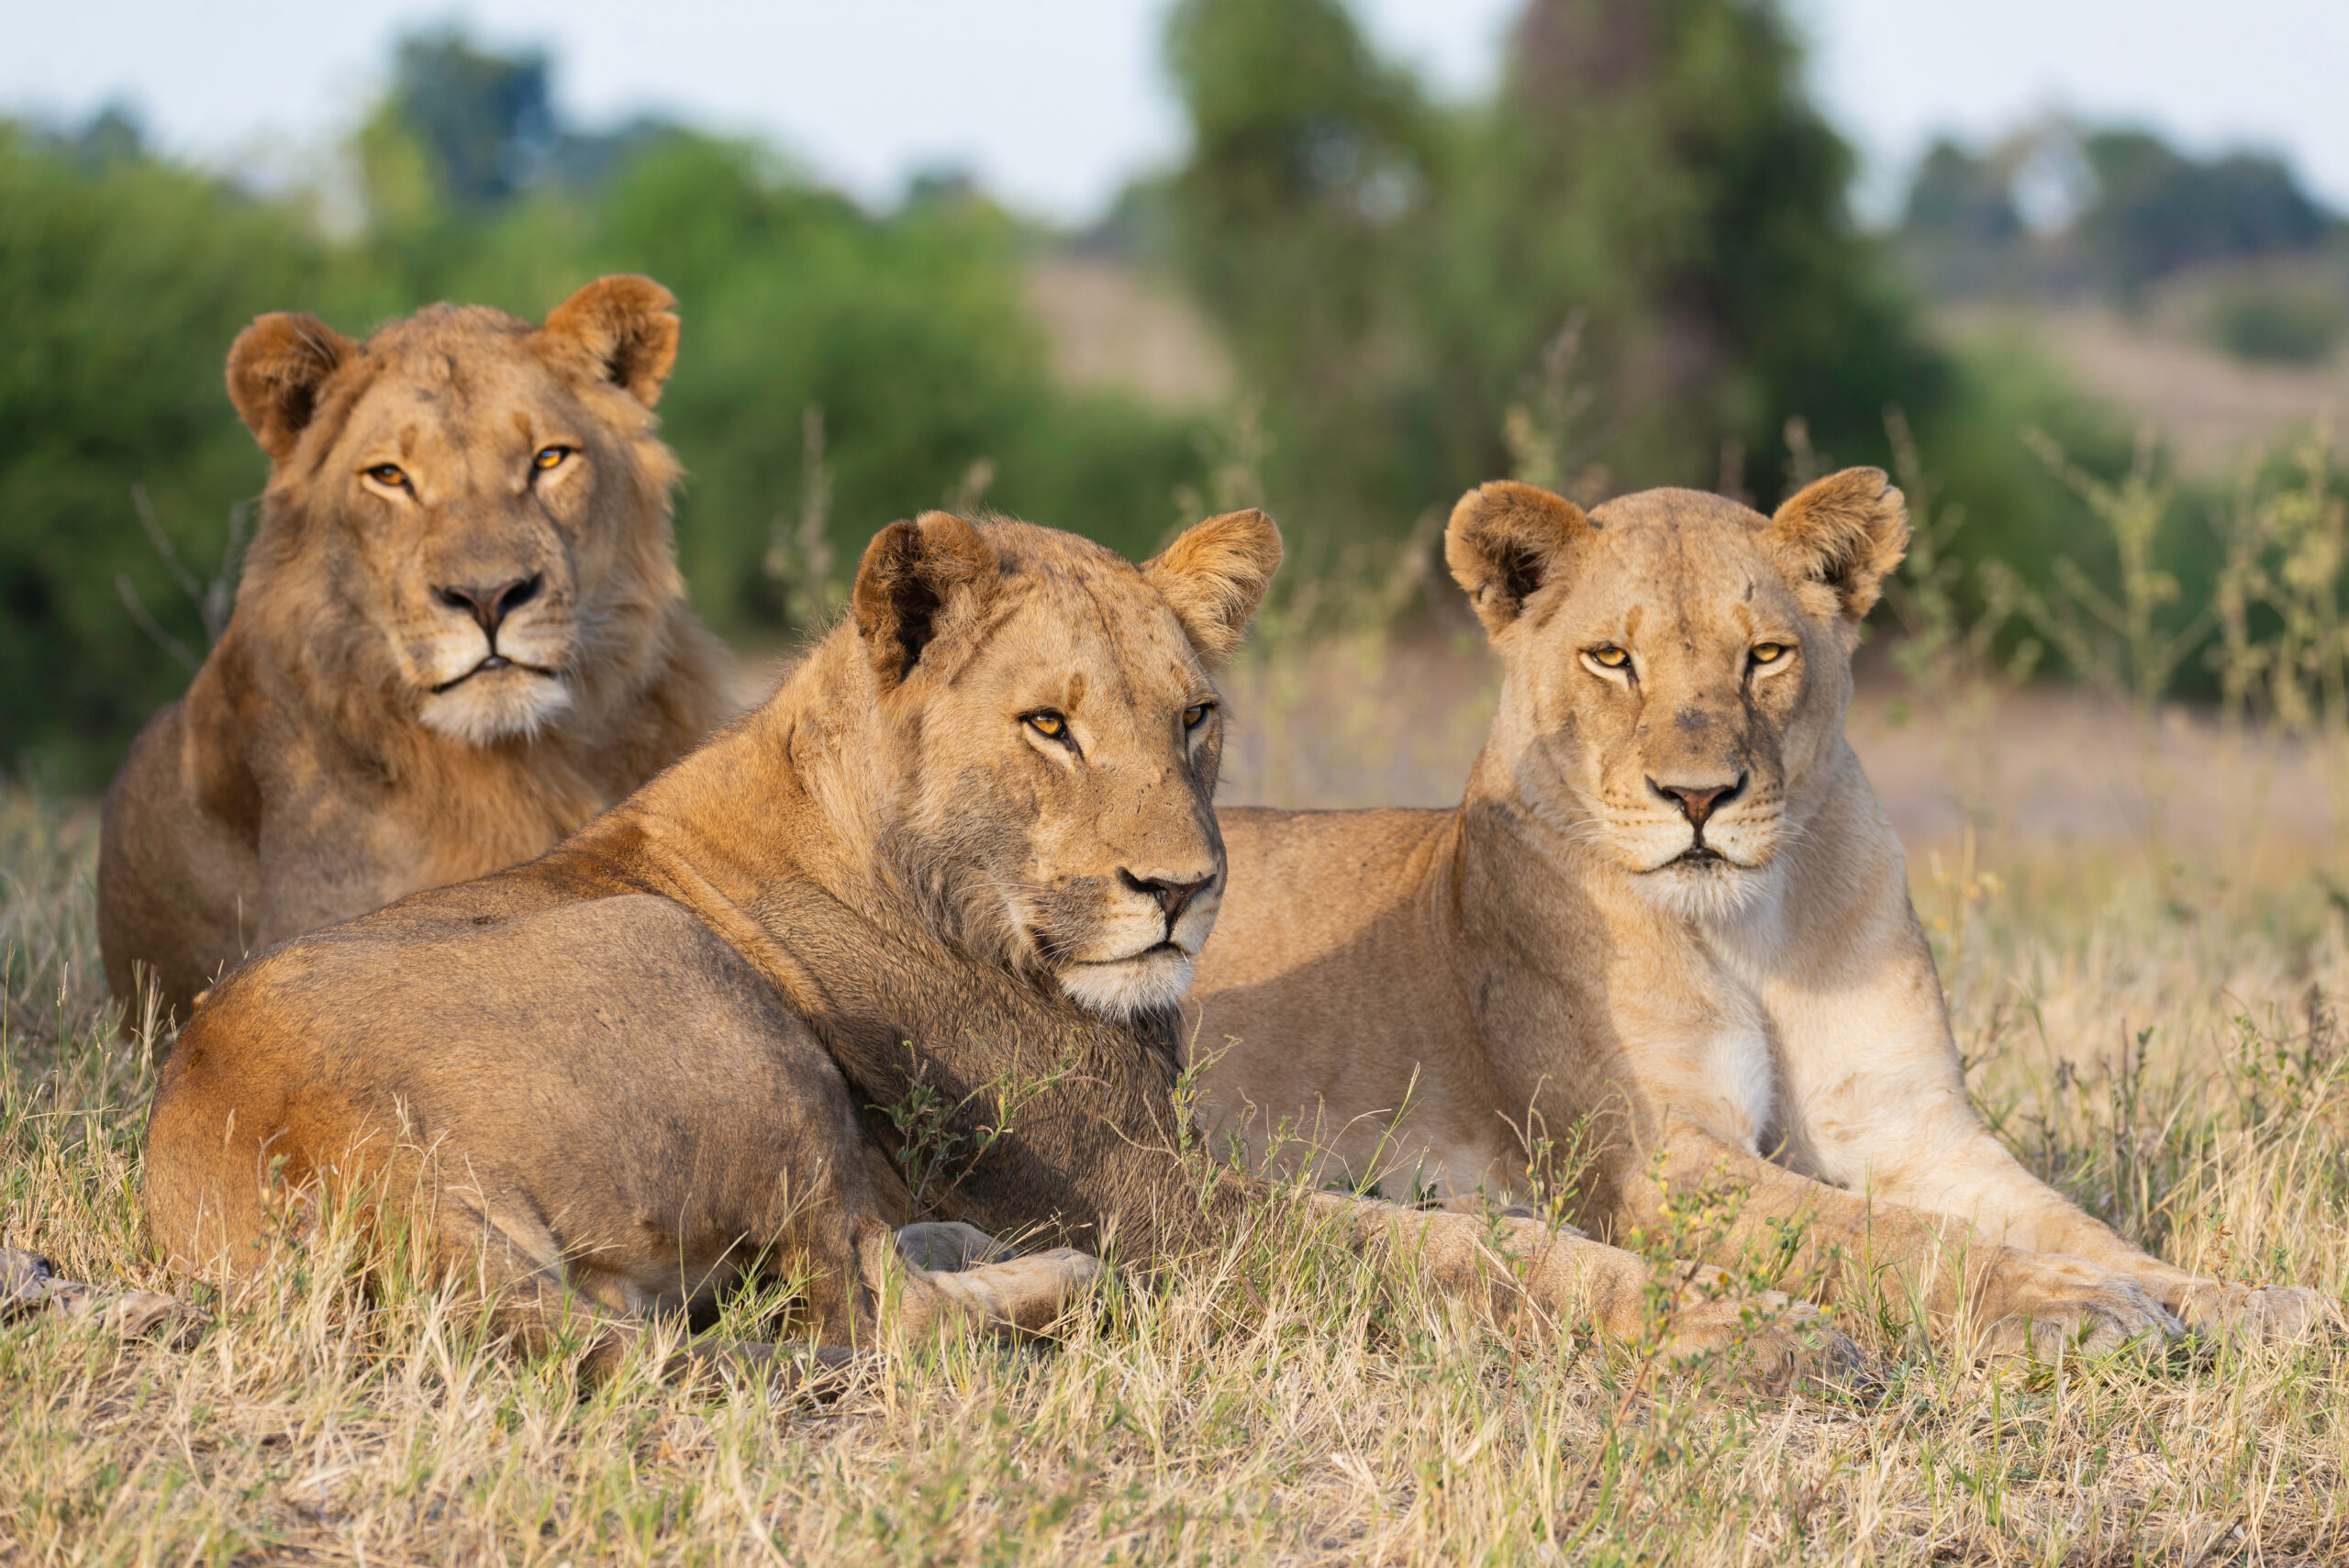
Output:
[0, 125, 327, 786]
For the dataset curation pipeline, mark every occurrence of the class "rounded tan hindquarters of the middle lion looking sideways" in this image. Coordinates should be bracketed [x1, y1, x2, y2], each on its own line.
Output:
[146, 866, 829, 1262]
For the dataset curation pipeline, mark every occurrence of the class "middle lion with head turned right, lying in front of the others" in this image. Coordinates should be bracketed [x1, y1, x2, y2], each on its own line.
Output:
[146, 512, 1851, 1375]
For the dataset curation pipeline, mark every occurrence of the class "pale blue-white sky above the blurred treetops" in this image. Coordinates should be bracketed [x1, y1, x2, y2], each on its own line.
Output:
[0, 0, 2349, 223]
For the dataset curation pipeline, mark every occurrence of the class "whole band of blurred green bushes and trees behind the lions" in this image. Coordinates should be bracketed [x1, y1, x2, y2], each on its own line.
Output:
[0, 0, 2349, 789]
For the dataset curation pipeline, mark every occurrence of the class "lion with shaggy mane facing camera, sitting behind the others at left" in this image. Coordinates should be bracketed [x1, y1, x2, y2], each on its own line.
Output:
[99, 277, 726, 1017]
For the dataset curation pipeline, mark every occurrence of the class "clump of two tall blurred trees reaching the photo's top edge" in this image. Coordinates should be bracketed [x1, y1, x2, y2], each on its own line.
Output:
[1167, 0, 1947, 530]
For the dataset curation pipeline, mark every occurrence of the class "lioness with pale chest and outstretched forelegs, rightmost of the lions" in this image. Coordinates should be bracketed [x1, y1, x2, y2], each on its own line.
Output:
[1196, 470, 2321, 1348]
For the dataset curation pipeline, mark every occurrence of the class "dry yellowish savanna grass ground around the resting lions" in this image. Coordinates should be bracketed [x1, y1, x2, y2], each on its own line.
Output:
[0, 619, 2349, 1565]
